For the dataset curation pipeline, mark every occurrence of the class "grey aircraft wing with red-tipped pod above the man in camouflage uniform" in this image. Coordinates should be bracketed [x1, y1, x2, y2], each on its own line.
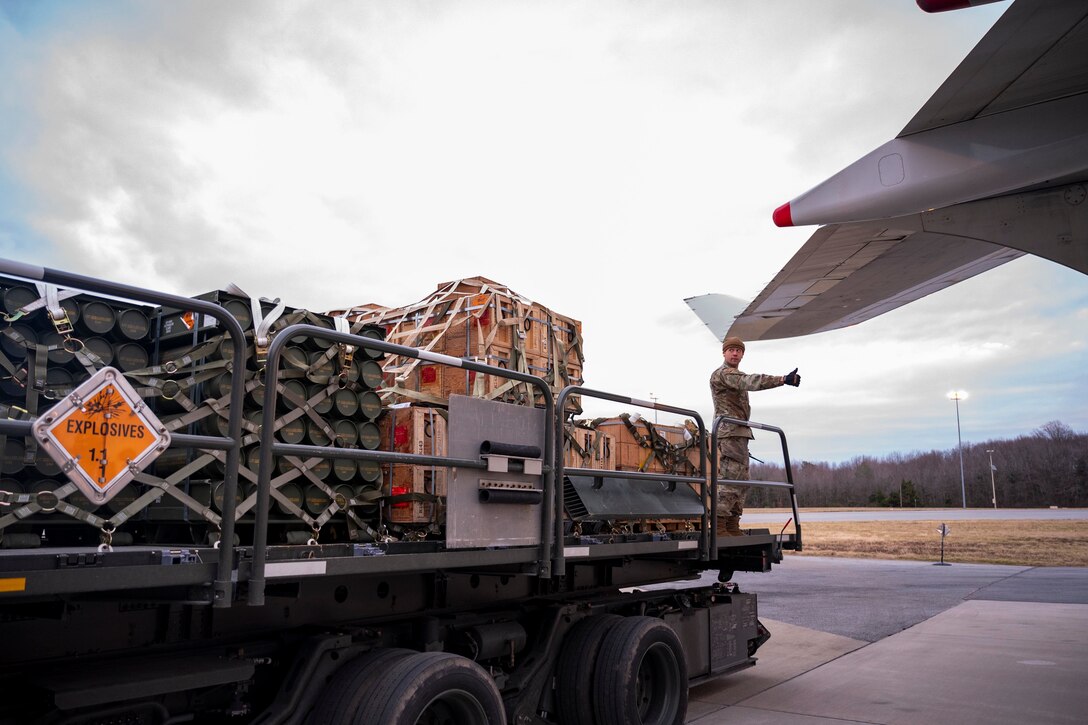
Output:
[713, 0, 1088, 340]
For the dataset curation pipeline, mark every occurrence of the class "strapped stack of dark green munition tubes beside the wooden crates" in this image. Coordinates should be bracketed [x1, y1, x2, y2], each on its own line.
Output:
[148, 292, 384, 543]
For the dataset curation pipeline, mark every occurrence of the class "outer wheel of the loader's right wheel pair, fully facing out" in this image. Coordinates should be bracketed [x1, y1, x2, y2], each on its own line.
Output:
[593, 616, 688, 725]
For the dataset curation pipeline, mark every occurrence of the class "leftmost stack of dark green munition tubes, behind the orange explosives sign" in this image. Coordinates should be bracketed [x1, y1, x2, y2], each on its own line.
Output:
[0, 278, 157, 548]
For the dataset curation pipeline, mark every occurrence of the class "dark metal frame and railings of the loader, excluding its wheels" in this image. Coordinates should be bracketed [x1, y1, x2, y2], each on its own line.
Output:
[0, 260, 801, 723]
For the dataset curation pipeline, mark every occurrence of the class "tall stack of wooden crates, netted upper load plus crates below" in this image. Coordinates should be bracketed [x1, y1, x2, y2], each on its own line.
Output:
[332, 277, 583, 528]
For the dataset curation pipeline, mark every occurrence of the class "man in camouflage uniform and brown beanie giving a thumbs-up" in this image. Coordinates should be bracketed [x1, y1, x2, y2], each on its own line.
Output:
[710, 337, 801, 537]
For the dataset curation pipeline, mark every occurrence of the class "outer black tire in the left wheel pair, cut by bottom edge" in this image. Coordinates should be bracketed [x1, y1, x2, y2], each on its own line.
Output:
[355, 652, 506, 725]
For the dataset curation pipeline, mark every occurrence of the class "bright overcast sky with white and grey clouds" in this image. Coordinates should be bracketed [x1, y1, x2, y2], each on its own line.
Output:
[0, 0, 1088, 462]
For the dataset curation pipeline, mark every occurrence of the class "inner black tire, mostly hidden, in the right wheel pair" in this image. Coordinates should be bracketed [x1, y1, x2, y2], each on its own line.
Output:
[555, 614, 623, 725]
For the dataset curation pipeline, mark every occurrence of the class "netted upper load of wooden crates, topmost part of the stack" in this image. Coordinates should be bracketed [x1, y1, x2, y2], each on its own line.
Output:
[345, 277, 583, 413]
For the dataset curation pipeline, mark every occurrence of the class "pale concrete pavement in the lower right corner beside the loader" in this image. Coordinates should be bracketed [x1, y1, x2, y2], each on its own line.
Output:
[687, 600, 1088, 725]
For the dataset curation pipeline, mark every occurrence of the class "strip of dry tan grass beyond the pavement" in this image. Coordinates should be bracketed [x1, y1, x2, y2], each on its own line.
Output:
[741, 515, 1088, 566]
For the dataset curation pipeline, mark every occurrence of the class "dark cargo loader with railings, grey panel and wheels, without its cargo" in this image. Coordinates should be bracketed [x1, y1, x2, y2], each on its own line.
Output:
[0, 260, 801, 725]
